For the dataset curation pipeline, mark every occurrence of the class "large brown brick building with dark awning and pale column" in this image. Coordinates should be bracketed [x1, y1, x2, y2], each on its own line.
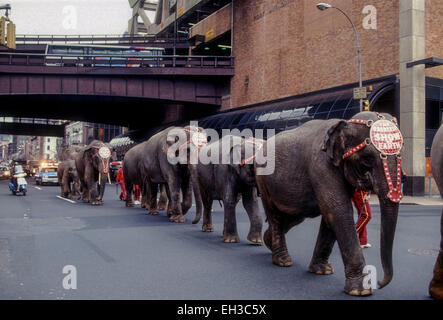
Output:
[126, 0, 443, 195]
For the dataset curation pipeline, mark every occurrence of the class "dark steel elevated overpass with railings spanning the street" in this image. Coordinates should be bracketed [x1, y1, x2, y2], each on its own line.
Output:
[0, 36, 234, 133]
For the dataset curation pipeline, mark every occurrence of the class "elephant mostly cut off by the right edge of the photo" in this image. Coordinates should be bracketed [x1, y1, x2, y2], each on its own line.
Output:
[429, 126, 443, 300]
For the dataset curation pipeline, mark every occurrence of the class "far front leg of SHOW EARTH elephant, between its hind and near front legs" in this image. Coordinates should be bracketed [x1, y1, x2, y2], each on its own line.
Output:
[309, 218, 336, 275]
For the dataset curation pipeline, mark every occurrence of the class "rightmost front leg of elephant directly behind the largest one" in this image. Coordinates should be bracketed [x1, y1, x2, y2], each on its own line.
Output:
[242, 188, 263, 243]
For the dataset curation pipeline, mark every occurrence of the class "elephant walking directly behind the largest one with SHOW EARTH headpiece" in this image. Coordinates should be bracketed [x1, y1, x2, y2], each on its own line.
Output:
[191, 135, 263, 244]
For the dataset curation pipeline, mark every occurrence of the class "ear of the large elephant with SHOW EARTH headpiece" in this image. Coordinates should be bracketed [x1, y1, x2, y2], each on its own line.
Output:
[322, 120, 347, 167]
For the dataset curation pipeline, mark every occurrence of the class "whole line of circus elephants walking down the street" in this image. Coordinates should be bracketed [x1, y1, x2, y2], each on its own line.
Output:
[58, 111, 443, 299]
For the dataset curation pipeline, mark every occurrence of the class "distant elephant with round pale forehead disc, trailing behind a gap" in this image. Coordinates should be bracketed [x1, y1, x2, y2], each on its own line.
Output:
[75, 140, 115, 205]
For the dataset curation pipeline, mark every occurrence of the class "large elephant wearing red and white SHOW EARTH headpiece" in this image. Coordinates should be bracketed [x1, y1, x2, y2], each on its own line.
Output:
[255, 111, 403, 296]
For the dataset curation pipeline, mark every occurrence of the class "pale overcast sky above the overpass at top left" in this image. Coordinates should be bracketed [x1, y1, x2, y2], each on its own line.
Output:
[5, 0, 137, 35]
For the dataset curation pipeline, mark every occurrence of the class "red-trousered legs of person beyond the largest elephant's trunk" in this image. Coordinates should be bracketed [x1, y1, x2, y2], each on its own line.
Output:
[352, 189, 372, 248]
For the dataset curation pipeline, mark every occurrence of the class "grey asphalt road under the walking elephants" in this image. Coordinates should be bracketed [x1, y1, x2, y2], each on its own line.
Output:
[0, 181, 441, 300]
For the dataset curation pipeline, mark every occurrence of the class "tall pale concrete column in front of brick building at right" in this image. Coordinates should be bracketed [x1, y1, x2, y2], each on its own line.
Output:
[399, 0, 426, 196]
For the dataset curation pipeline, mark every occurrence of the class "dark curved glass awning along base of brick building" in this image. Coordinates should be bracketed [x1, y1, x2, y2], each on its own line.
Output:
[199, 76, 396, 133]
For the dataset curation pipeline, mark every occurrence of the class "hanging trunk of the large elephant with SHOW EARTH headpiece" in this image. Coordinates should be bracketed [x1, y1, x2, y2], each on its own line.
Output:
[378, 196, 399, 288]
